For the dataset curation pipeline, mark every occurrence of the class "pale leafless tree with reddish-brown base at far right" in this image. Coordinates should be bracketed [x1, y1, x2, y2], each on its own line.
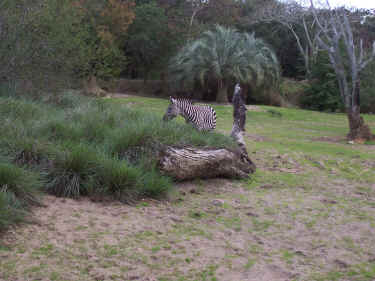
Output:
[310, 0, 375, 141]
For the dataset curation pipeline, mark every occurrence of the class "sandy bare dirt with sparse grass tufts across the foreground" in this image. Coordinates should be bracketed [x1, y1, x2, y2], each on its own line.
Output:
[0, 174, 375, 281]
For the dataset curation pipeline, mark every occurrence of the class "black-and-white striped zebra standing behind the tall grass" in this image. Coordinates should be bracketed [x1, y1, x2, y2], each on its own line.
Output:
[163, 97, 216, 131]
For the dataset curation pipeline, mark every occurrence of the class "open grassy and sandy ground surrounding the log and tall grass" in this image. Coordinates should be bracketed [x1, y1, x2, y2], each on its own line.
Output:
[0, 93, 375, 281]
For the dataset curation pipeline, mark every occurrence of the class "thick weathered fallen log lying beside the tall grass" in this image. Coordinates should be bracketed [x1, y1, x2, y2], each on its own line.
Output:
[159, 146, 256, 180]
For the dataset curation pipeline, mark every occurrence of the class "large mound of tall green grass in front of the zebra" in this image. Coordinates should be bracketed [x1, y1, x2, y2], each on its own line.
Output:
[0, 93, 236, 207]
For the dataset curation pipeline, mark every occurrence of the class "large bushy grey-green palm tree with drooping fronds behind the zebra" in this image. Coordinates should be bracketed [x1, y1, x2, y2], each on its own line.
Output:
[169, 25, 279, 102]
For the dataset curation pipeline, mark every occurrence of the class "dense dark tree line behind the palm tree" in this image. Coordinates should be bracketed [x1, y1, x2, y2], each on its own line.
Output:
[0, 0, 375, 116]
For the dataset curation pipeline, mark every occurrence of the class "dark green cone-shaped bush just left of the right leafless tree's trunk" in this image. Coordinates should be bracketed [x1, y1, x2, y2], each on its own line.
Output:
[301, 53, 343, 111]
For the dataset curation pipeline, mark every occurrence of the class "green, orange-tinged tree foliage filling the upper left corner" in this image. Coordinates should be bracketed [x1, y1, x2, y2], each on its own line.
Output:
[0, 0, 134, 92]
